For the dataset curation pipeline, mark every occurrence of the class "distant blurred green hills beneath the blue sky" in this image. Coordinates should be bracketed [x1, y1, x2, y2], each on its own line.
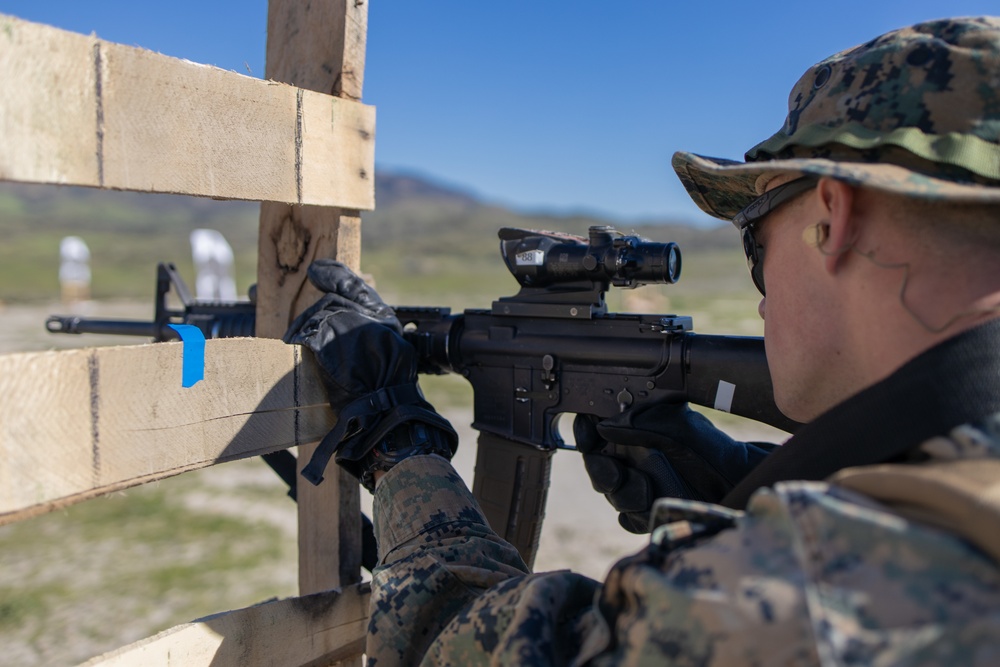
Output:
[0, 170, 735, 301]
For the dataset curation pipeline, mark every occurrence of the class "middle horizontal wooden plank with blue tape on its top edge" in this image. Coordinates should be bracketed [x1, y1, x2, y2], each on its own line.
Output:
[0, 338, 334, 525]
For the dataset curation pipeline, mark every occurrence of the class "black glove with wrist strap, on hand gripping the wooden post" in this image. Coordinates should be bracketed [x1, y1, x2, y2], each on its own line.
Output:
[284, 259, 458, 491]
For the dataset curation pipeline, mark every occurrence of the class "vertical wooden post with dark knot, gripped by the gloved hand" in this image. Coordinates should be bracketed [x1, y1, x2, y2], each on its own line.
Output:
[257, 0, 374, 595]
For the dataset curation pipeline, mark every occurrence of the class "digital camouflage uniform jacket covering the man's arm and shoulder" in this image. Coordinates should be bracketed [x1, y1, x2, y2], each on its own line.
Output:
[368, 417, 1000, 667]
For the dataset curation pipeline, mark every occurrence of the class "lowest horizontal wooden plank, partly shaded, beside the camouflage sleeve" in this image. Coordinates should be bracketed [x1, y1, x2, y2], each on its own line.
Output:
[77, 584, 371, 667]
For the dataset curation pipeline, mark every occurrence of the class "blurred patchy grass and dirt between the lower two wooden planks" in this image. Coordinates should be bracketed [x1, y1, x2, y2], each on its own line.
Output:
[0, 460, 297, 665]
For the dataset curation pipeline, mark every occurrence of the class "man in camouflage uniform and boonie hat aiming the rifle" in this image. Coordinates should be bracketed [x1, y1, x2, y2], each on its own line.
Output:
[288, 18, 1000, 667]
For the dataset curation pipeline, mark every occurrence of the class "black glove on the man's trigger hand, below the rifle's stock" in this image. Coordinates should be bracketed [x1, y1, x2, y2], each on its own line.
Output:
[573, 403, 776, 533]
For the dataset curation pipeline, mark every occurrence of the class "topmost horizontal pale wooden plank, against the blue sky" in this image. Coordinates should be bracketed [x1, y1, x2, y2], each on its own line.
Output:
[0, 15, 375, 210]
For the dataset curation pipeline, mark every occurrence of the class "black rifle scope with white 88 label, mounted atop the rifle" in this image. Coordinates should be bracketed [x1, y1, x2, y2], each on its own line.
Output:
[500, 225, 681, 288]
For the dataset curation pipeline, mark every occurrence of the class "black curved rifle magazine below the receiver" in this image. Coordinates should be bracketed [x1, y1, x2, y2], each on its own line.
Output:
[472, 432, 554, 568]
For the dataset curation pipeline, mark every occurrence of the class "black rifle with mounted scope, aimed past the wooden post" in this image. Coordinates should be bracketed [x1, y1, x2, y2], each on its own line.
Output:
[46, 226, 799, 565]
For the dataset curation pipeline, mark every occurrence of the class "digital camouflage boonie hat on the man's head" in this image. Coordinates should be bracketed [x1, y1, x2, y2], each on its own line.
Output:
[673, 17, 1000, 226]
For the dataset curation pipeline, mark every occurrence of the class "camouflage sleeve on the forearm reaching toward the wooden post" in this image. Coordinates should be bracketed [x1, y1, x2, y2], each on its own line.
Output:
[366, 456, 600, 667]
